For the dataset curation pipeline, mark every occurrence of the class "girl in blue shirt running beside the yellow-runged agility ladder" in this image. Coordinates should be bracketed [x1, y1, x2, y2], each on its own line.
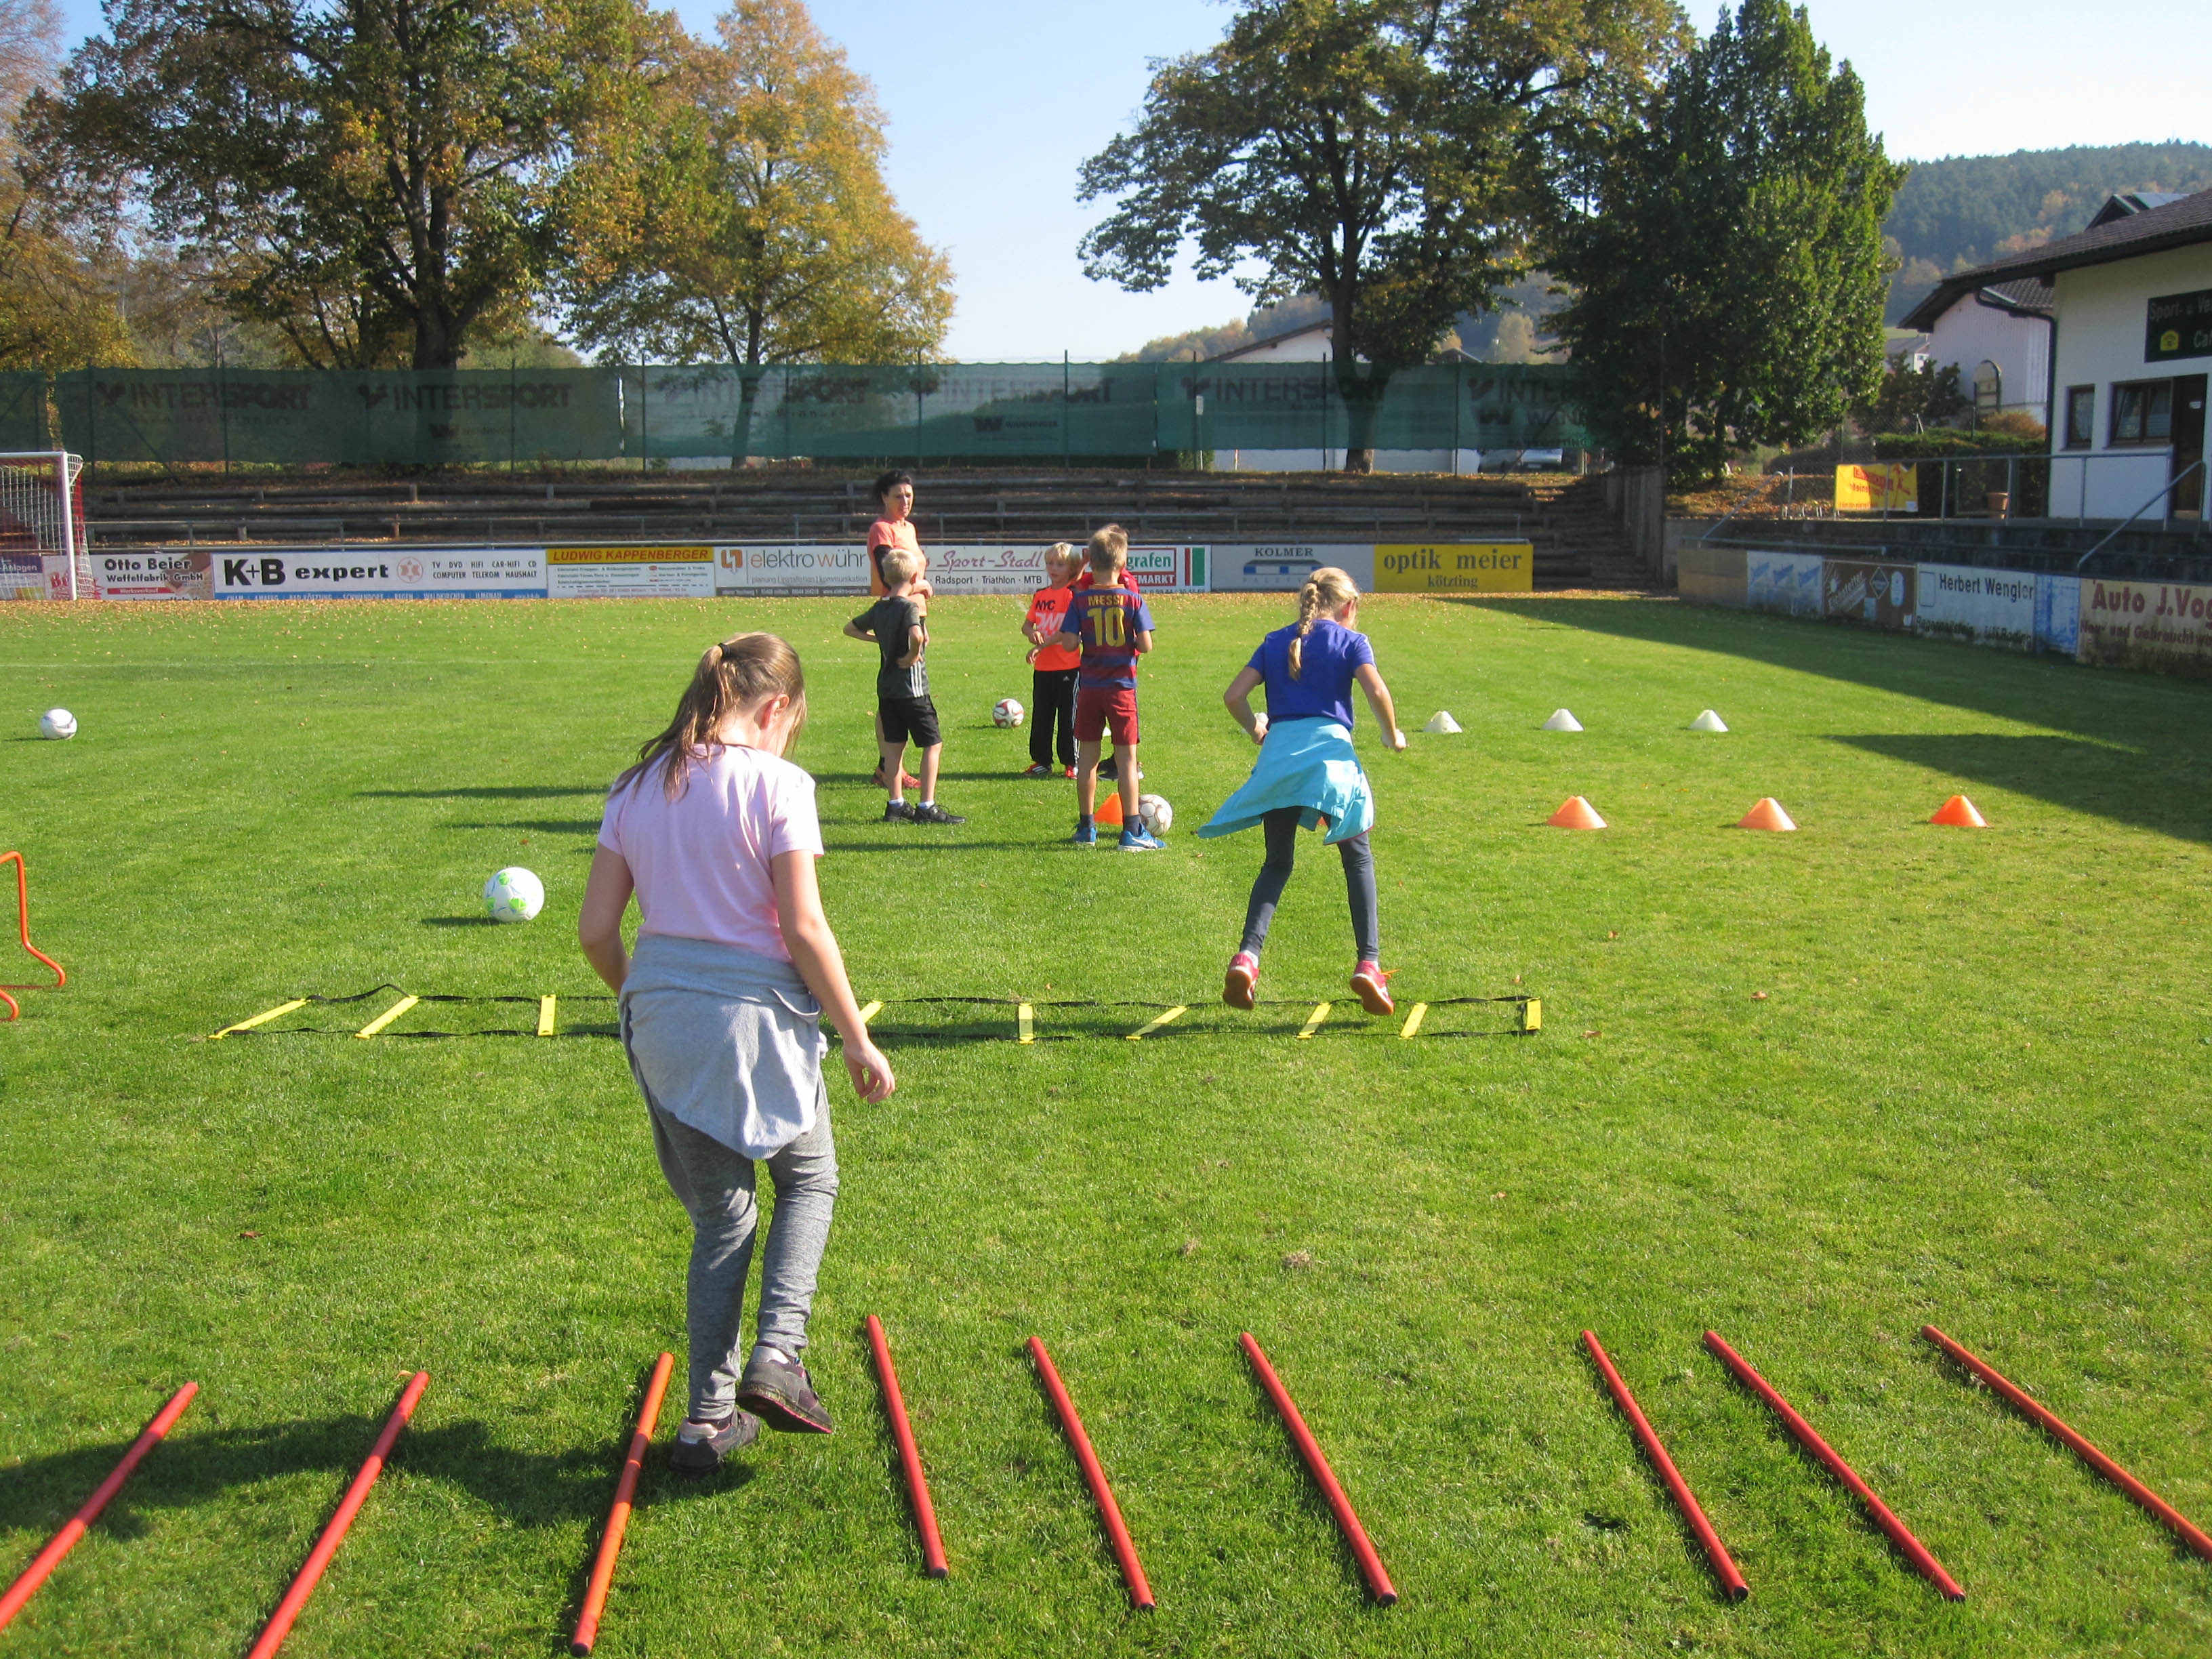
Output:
[1199, 564, 1405, 1013]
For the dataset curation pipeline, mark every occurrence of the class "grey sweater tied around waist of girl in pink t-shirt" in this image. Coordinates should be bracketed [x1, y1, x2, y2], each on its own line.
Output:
[621, 933, 830, 1159]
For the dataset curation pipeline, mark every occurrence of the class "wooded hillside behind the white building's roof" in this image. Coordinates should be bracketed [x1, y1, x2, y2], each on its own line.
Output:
[1883, 144, 2212, 323]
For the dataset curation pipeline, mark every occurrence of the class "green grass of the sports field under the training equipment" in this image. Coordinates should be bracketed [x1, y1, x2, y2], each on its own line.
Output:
[0, 600, 2212, 1659]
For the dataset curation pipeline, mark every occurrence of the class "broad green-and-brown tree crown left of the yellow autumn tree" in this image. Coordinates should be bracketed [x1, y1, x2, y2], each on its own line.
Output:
[26, 0, 668, 369]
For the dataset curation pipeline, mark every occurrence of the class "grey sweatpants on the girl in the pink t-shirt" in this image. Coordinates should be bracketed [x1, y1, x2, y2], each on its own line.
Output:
[646, 1101, 836, 1420]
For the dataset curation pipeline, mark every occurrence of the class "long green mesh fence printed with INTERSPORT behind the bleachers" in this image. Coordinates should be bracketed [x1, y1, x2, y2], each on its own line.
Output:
[47, 363, 1589, 464]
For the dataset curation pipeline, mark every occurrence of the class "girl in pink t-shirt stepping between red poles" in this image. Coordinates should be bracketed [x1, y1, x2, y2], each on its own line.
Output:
[577, 633, 898, 1475]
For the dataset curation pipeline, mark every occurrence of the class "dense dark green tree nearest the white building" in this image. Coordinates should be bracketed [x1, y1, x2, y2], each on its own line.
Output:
[1549, 0, 1904, 480]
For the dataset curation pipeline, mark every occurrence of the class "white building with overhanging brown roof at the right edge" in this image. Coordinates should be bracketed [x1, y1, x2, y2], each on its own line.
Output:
[1907, 190, 2212, 522]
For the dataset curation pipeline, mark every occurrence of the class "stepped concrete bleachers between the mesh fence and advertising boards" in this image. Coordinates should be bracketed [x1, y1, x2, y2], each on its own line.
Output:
[84, 469, 1641, 588]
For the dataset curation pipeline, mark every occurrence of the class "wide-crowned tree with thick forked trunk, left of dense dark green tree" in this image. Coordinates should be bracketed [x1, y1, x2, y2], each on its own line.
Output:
[1080, 0, 1679, 471]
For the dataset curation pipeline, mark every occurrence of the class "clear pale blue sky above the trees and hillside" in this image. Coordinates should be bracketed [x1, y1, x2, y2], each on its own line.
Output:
[43, 0, 2212, 361]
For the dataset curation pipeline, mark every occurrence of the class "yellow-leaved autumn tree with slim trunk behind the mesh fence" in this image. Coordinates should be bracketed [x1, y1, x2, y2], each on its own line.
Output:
[569, 0, 954, 458]
